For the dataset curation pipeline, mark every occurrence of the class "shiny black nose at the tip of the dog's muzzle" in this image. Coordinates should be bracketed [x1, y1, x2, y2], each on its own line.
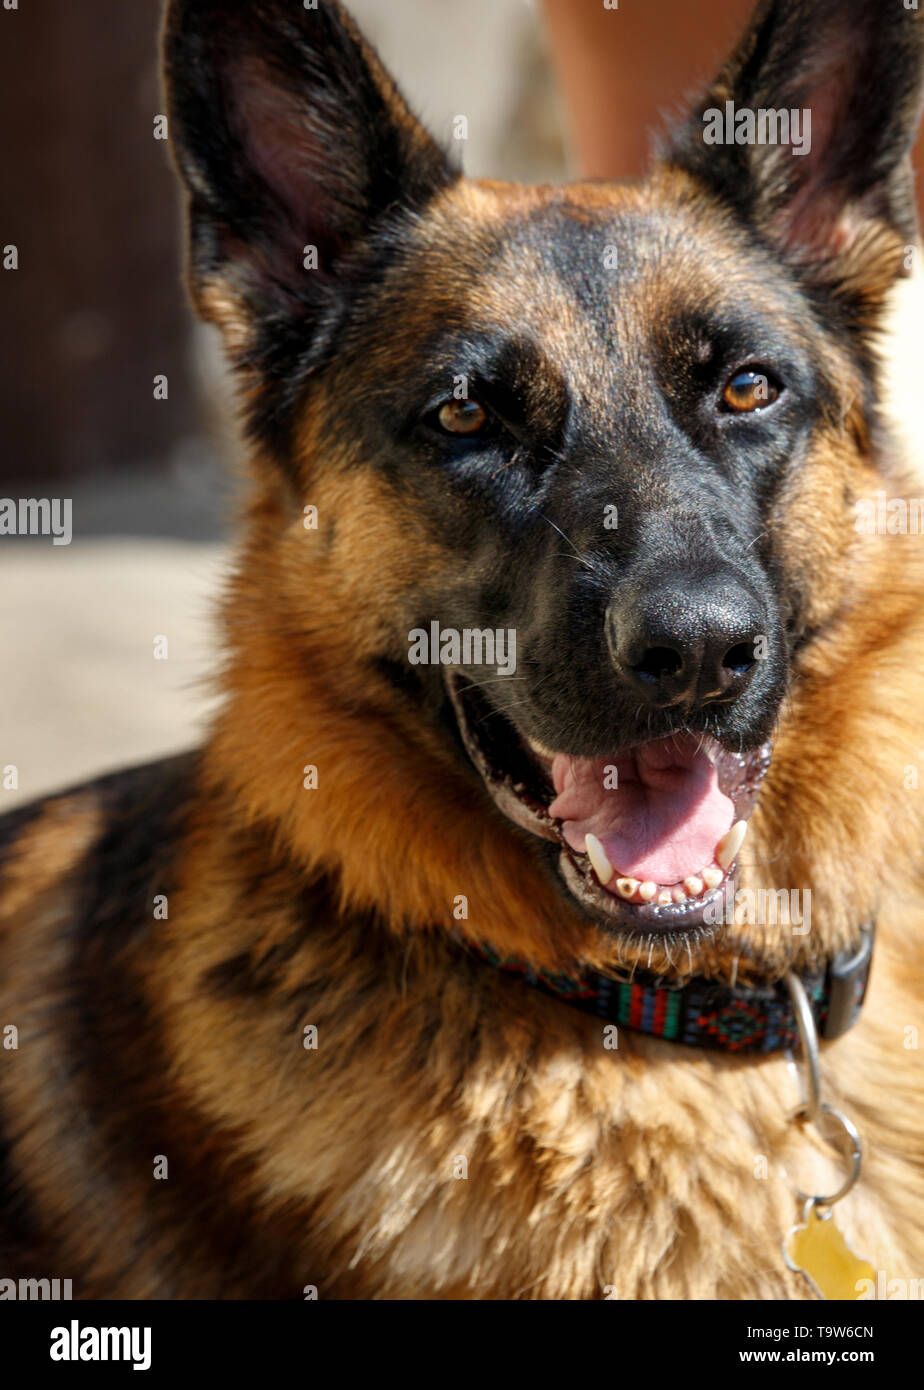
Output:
[607, 575, 768, 708]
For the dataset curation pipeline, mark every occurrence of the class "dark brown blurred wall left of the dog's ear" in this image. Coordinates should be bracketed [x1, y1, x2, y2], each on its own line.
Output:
[0, 0, 196, 482]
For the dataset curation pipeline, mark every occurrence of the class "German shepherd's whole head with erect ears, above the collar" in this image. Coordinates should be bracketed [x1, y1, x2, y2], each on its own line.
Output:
[165, 0, 923, 978]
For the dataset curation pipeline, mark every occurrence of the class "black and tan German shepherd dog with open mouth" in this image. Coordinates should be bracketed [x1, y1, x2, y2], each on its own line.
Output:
[0, 0, 924, 1300]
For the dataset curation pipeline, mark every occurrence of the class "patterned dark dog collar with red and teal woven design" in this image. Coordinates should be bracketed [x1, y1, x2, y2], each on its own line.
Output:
[457, 923, 875, 1052]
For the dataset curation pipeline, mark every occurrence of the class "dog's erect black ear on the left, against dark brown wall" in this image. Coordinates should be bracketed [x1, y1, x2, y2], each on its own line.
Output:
[164, 0, 457, 355]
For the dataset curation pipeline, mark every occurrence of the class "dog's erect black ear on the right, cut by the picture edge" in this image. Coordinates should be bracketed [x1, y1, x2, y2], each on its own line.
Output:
[664, 0, 924, 320]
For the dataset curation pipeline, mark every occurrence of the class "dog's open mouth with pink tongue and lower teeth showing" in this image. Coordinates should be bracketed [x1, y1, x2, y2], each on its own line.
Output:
[447, 674, 770, 934]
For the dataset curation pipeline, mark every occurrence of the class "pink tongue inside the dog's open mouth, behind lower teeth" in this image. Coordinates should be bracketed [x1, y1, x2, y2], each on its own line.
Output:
[549, 738, 735, 884]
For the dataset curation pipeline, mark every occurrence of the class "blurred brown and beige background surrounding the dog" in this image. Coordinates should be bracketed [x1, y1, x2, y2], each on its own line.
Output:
[0, 0, 921, 812]
